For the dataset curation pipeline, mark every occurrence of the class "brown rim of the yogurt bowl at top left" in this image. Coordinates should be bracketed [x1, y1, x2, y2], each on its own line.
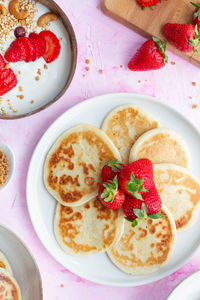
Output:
[0, 0, 78, 120]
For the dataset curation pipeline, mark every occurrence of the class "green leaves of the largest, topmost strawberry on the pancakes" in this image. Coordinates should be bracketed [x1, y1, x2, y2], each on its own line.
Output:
[127, 173, 148, 201]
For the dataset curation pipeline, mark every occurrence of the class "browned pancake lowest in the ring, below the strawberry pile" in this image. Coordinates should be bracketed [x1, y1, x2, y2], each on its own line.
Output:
[107, 206, 176, 275]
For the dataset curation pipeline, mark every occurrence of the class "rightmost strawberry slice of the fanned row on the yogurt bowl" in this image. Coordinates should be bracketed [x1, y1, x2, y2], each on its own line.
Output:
[39, 30, 61, 63]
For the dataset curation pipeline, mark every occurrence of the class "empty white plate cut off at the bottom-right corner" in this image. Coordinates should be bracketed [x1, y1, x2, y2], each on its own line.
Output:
[167, 271, 200, 300]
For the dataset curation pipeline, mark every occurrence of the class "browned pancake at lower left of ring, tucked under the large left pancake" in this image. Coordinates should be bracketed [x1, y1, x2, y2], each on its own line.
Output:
[54, 197, 124, 256]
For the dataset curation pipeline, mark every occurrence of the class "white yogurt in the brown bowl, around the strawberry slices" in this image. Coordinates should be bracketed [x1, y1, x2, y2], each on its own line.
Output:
[0, 1, 72, 116]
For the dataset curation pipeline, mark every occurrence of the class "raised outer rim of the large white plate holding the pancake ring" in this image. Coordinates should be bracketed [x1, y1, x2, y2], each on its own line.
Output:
[26, 92, 200, 287]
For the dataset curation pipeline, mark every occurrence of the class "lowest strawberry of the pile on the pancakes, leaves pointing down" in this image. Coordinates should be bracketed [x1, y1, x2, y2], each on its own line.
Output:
[123, 191, 163, 227]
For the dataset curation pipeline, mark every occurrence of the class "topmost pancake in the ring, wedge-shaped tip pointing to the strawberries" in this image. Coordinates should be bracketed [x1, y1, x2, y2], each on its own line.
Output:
[101, 104, 159, 163]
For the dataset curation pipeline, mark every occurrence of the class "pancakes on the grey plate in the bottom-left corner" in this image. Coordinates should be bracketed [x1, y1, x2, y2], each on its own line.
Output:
[0, 252, 22, 300]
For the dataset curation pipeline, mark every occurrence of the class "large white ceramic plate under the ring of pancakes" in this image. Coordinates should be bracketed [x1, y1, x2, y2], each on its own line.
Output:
[27, 93, 200, 286]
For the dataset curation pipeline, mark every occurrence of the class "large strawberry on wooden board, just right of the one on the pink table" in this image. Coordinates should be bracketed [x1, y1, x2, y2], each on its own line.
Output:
[163, 23, 200, 52]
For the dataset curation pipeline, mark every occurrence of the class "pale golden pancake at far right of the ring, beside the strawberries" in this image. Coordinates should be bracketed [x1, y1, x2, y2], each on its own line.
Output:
[153, 164, 200, 231]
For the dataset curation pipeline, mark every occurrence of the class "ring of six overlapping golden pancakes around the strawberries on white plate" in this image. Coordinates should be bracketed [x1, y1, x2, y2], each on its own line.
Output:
[44, 104, 200, 274]
